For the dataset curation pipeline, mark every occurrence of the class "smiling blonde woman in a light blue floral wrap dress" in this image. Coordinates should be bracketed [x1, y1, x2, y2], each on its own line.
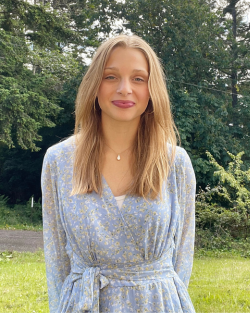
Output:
[42, 35, 195, 313]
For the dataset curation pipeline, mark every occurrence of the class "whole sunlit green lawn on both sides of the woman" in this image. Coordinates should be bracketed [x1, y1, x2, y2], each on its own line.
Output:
[0, 251, 250, 313]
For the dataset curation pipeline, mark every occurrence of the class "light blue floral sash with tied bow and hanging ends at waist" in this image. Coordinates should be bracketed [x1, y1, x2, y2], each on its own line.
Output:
[57, 254, 177, 313]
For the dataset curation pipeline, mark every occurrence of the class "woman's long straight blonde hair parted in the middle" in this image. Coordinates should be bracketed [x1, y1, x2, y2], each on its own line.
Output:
[72, 35, 178, 199]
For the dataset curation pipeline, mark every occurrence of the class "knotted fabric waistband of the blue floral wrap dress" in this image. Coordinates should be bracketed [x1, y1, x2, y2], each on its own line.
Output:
[58, 254, 177, 313]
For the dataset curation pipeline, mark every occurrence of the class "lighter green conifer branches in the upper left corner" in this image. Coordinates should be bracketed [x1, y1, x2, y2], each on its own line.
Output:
[0, 0, 78, 151]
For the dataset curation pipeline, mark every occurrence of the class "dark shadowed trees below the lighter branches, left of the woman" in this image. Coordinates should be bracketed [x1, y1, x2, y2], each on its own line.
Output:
[0, 67, 86, 203]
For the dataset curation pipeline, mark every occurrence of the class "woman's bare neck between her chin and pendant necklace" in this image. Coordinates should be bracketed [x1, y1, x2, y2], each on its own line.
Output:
[101, 114, 140, 153]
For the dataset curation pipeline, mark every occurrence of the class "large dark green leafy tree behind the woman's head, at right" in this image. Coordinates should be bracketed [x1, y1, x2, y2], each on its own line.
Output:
[111, 0, 250, 187]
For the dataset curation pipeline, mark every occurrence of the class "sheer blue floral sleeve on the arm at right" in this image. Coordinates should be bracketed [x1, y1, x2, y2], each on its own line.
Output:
[173, 149, 196, 287]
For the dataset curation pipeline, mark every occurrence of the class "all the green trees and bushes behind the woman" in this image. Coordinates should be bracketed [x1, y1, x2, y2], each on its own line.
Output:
[0, 0, 250, 249]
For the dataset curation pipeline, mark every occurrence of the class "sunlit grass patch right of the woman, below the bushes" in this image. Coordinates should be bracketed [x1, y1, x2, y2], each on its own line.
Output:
[189, 252, 250, 313]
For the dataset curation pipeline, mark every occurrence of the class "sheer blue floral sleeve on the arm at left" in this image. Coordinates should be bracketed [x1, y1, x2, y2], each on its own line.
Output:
[41, 149, 70, 313]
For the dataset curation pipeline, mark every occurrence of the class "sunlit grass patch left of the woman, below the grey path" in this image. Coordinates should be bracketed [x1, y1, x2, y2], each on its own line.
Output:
[0, 251, 49, 313]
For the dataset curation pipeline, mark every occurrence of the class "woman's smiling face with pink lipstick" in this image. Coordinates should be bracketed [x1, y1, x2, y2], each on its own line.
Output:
[97, 47, 149, 122]
